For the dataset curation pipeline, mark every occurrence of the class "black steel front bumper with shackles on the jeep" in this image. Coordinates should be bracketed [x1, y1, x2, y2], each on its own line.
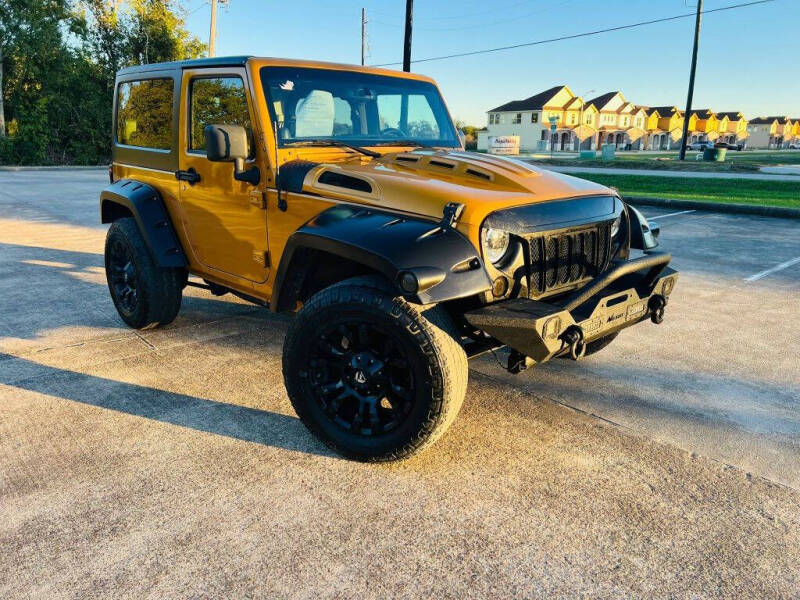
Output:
[464, 252, 678, 368]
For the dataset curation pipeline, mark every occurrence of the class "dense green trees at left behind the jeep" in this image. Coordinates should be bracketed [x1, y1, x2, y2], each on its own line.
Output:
[0, 0, 206, 165]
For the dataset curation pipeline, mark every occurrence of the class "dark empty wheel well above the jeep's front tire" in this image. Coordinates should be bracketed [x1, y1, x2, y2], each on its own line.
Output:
[278, 248, 383, 312]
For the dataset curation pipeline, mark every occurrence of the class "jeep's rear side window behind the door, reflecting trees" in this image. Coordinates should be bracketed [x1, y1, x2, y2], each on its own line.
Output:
[117, 79, 174, 150]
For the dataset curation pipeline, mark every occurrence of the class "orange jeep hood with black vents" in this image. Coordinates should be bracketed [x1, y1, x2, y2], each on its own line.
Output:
[288, 150, 611, 225]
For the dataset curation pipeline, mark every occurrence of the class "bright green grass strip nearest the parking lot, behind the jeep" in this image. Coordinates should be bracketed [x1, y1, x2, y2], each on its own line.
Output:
[575, 173, 800, 208]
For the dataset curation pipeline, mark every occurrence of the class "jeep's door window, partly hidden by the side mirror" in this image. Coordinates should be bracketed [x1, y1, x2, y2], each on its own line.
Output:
[189, 77, 255, 158]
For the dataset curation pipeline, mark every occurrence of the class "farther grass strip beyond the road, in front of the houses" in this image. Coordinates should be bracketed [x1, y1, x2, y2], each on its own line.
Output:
[536, 150, 800, 173]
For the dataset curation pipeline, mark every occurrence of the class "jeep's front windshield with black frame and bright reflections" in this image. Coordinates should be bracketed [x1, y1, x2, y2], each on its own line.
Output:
[261, 67, 460, 148]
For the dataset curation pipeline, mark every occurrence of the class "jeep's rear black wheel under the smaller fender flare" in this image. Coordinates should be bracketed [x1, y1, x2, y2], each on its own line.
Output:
[105, 218, 185, 329]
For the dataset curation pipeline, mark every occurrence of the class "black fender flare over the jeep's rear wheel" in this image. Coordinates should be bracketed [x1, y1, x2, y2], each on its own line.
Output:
[100, 179, 189, 267]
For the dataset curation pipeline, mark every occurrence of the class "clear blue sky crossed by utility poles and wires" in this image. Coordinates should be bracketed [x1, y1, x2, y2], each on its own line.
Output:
[185, 0, 800, 125]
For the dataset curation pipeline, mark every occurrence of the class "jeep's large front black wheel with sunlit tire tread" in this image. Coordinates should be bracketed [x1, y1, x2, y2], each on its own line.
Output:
[283, 278, 468, 461]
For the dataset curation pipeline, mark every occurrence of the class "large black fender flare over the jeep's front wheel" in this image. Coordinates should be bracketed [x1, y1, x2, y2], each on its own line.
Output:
[270, 204, 492, 312]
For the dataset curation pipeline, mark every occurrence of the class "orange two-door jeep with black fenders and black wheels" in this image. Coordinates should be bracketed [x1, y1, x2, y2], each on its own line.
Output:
[100, 57, 677, 460]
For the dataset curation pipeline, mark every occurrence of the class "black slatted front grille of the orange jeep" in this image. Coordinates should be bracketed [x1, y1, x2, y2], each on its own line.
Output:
[526, 223, 611, 297]
